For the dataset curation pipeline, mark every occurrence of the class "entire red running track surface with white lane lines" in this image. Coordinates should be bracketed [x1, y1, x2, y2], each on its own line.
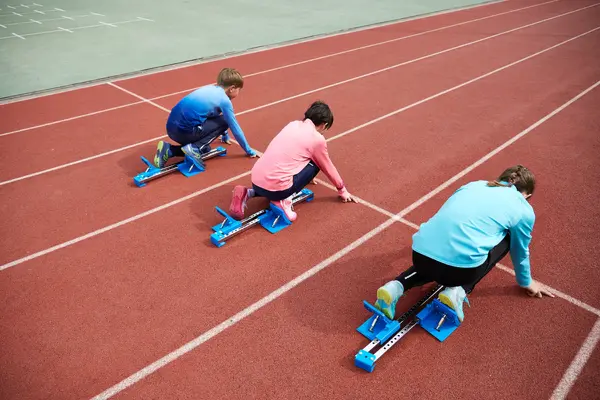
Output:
[0, 1, 600, 399]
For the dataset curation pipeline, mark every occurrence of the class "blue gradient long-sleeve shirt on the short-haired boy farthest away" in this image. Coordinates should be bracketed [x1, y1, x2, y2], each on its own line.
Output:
[167, 85, 254, 155]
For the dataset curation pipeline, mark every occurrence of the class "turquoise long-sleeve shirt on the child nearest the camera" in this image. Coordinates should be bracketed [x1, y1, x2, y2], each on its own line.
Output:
[413, 181, 535, 287]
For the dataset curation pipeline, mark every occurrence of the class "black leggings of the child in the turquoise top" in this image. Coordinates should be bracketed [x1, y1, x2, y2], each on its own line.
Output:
[396, 235, 510, 293]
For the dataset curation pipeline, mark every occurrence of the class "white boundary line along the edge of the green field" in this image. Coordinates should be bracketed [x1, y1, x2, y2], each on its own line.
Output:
[0, 0, 508, 105]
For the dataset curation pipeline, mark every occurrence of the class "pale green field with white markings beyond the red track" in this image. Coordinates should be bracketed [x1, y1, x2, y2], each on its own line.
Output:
[0, 0, 494, 98]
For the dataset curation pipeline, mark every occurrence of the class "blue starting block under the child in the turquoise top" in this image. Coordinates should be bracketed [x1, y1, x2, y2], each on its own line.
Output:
[354, 285, 460, 372]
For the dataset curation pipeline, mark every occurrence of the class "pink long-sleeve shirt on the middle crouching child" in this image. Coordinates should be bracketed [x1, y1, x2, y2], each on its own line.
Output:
[252, 119, 345, 193]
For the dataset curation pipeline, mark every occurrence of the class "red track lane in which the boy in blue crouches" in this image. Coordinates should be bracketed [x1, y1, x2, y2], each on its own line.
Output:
[0, 4, 598, 262]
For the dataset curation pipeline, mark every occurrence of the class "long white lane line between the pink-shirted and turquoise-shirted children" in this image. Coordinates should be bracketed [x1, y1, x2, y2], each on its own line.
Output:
[92, 81, 600, 400]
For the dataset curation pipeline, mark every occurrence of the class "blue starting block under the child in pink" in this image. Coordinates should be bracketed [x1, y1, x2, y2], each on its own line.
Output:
[210, 189, 314, 247]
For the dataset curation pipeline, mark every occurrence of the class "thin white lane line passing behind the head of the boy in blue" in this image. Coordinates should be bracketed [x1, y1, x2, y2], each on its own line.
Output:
[0, 0, 560, 137]
